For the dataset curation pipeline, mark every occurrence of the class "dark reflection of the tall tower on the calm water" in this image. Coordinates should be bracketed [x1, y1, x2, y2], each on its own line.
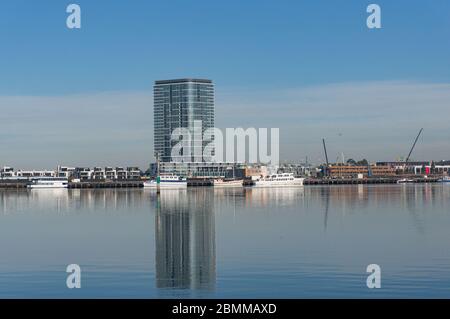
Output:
[155, 190, 216, 289]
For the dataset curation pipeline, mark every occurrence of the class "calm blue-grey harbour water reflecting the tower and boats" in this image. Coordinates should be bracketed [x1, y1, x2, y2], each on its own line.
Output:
[0, 185, 450, 298]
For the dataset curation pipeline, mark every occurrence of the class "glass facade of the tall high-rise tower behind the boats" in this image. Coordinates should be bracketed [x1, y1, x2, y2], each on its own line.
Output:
[153, 79, 214, 162]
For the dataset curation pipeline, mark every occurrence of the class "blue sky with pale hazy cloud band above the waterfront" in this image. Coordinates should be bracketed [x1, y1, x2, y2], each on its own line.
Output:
[0, 0, 450, 168]
